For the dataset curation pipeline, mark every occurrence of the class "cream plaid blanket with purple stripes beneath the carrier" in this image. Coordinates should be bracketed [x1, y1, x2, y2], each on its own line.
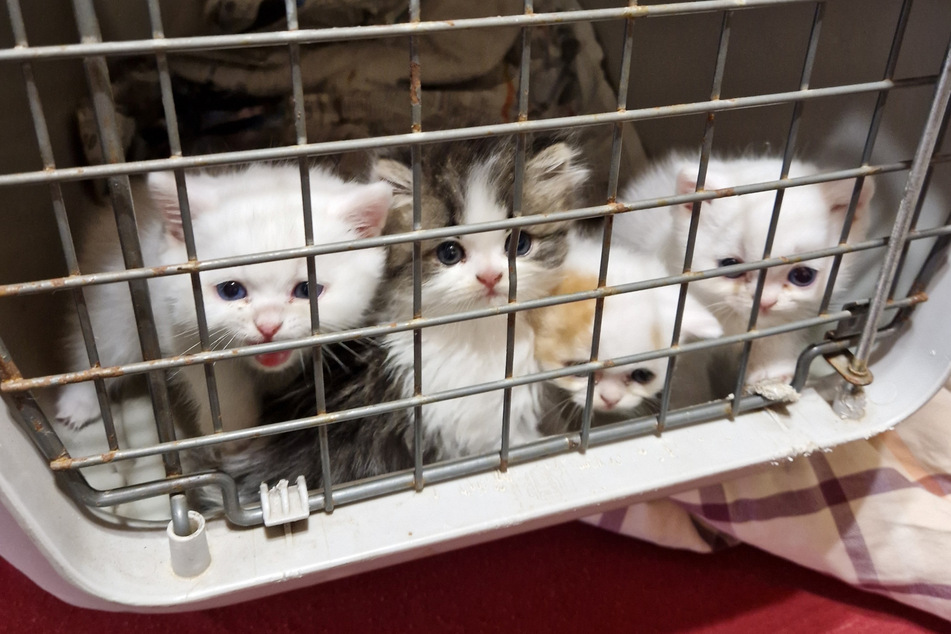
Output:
[586, 382, 951, 620]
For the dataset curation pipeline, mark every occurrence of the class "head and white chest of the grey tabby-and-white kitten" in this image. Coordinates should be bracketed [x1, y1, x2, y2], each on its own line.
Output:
[377, 139, 588, 457]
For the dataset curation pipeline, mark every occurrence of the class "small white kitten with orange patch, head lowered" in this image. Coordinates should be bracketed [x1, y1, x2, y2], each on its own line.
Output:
[529, 233, 722, 422]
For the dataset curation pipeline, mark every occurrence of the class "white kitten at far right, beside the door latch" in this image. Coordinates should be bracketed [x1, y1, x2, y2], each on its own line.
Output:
[614, 154, 874, 386]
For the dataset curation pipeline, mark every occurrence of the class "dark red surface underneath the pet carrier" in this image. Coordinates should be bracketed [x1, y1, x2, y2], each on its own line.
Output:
[0, 523, 951, 634]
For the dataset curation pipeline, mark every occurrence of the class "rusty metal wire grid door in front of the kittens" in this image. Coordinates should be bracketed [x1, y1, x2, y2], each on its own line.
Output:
[0, 0, 951, 534]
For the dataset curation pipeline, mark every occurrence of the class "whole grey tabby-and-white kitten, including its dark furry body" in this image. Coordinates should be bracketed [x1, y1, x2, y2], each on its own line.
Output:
[206, 139, 588, 500]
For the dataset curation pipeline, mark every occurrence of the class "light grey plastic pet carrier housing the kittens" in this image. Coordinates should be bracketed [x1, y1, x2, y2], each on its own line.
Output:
[0, 0, 951, 611]
